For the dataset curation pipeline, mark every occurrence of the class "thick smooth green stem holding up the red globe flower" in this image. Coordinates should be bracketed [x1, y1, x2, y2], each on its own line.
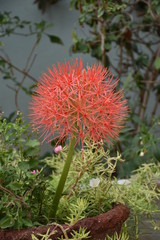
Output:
[51, 136, 76, 218]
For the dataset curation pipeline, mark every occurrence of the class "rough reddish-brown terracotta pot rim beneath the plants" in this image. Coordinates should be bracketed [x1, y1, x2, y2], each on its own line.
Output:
[0, 204, 129, 240]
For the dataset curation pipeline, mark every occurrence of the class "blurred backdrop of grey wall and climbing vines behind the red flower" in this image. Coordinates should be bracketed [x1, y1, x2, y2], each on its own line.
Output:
[0, 0, 160, 177]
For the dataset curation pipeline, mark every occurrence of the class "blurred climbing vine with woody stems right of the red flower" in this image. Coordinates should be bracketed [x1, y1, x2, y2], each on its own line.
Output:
[70, 0, 160, 177]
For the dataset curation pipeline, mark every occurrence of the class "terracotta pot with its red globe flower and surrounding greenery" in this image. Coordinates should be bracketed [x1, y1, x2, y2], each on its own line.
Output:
[0, 60, 159, 240]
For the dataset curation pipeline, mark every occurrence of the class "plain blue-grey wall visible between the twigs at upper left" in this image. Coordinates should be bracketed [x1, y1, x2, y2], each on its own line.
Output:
[0, 0, 96, 116]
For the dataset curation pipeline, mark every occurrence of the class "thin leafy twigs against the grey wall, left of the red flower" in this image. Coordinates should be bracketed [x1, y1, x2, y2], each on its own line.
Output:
[0, 12, 63, 110]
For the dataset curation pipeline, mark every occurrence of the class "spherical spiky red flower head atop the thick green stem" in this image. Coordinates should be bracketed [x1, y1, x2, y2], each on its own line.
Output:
[30, 60, 127, 142]
